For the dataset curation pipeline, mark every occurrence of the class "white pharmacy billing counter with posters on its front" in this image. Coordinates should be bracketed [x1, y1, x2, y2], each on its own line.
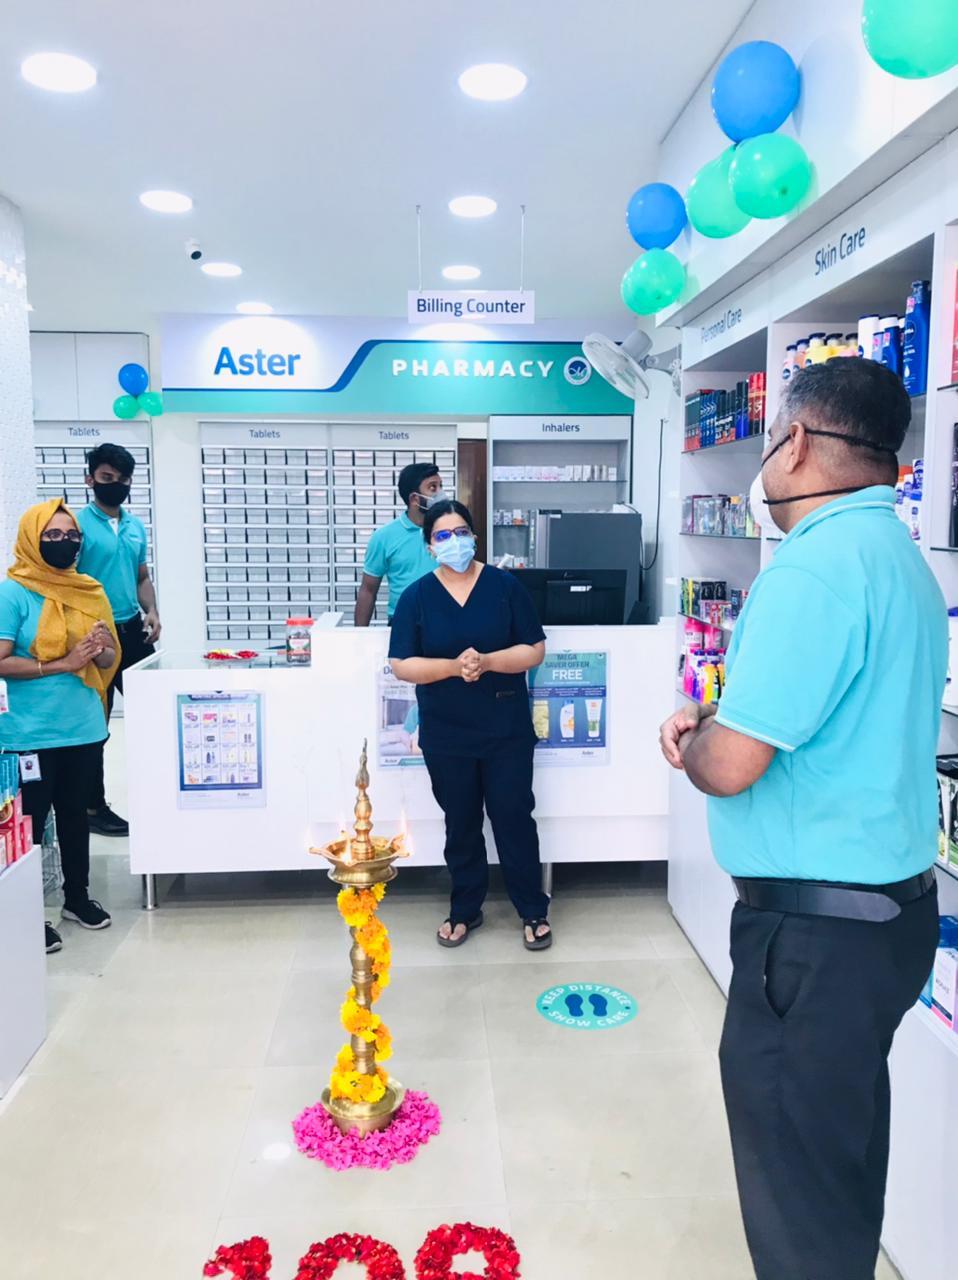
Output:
[124, 620, 675, 877]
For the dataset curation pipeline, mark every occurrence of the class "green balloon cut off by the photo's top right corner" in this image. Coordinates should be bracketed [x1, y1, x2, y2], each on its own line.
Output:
[862, 0, 958, 79]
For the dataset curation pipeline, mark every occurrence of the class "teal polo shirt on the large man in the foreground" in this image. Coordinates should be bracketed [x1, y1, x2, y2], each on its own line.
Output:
[708, 485, 948, 884]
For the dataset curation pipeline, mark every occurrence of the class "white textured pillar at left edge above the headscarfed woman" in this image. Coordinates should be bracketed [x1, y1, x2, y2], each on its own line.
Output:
[0, 196, 37, 552]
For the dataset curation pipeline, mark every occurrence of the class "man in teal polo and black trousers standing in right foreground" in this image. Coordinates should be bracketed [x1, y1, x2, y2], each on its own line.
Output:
[662, 360, 948, 1280]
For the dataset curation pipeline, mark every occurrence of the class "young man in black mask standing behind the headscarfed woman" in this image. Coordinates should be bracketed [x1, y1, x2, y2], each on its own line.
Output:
[77, 444, 160, 836]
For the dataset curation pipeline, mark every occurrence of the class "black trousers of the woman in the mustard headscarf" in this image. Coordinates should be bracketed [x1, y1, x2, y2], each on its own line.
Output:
[23, 742, 102, 906]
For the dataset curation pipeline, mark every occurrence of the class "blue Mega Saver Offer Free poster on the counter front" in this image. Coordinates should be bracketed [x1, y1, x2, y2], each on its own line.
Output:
[529, 653, 608, 765]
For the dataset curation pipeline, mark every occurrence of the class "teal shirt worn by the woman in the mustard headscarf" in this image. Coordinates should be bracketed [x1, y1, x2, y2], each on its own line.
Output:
[0, 577, 106, 747]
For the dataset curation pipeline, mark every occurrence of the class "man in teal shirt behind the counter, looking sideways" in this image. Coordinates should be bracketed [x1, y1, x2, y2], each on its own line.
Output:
[353, 462, 446, 627]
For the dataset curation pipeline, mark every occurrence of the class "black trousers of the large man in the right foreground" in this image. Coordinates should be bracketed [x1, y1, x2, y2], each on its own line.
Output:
[720, 890, 938, 1280]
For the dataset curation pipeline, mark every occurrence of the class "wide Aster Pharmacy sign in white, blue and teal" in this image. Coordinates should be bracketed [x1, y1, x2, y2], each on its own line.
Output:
[163, 312, 633, 416]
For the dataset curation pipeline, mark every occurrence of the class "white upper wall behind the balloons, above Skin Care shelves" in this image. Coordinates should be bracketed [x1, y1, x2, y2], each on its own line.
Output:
[656, 0, 958, 315]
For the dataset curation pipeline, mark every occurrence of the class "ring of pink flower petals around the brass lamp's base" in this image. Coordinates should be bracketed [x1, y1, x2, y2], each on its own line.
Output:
[293, 1089, 442, 1169]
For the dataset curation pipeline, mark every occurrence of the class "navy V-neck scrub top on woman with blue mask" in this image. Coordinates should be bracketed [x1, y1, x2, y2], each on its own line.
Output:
[389, 564, 546, 756]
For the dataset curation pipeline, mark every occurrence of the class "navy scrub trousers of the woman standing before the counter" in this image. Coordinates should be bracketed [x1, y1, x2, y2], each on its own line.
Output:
[423, 745, 549, 924]
